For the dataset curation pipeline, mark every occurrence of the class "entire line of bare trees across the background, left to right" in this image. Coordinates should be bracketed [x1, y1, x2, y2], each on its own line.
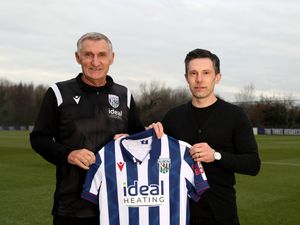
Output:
[0, 79, 300, 128]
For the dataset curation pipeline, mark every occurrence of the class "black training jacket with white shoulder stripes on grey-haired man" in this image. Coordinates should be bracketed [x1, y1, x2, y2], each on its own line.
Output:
[30, 74, 144, 217]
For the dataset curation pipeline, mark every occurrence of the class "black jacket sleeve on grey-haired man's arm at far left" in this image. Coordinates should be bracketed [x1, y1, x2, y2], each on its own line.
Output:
[30, 88, 71, 165]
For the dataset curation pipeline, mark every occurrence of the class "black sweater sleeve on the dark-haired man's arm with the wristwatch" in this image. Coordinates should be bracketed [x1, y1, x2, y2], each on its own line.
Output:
[216, 109, 260, 176]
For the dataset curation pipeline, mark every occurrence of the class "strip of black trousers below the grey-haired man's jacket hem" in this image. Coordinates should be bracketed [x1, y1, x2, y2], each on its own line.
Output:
[53, 216, 100, 225]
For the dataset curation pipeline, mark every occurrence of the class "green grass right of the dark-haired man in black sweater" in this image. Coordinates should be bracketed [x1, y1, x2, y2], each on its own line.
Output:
[236, 136, 300, 225]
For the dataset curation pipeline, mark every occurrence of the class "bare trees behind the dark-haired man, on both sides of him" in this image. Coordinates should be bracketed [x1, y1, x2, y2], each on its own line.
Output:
[137, 82, 300, 128]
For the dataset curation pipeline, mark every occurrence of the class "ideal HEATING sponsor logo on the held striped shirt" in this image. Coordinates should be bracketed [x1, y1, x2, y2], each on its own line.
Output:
[123, 180, 165, 207]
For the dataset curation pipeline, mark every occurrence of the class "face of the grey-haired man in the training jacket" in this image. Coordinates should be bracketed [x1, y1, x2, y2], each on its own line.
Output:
[76, 39, 114, 86]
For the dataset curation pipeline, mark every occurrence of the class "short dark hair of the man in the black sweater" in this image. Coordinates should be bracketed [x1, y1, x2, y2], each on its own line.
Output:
[184, 48, 220, 75]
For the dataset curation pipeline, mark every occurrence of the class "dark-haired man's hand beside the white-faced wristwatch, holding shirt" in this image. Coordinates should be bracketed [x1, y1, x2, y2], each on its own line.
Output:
[190, 142, 215, 163]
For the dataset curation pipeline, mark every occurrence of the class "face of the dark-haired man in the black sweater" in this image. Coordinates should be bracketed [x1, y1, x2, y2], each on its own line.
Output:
[186, 58, 221, 100]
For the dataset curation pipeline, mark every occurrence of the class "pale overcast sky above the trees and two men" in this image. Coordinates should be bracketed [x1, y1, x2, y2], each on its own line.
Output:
[0, 0, 300, 101]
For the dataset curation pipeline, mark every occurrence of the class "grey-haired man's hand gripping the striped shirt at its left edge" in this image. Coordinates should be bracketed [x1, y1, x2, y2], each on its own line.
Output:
[68, 148, 96, 170]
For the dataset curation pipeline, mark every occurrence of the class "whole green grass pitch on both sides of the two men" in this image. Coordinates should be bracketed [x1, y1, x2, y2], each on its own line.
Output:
[0, 131, 300, 225]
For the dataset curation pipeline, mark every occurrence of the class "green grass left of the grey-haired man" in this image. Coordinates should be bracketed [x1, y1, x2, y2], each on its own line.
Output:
[0, 131, 55, 225]
